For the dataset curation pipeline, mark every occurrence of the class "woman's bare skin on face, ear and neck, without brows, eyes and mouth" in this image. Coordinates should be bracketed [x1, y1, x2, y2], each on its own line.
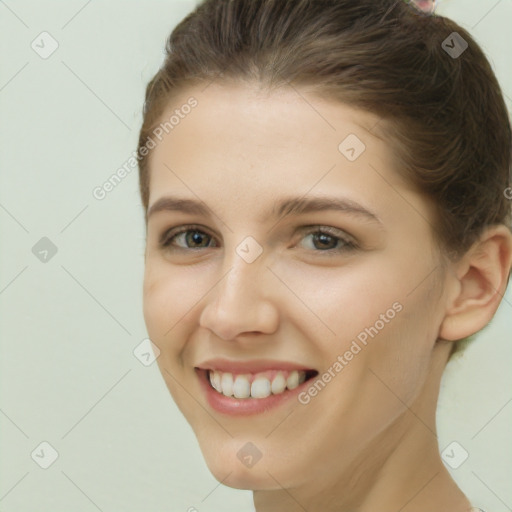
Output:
[144, 83, 512, 512]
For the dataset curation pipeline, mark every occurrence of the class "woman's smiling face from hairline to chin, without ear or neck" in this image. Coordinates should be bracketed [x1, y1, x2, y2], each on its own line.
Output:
[144, 83, 448, 489]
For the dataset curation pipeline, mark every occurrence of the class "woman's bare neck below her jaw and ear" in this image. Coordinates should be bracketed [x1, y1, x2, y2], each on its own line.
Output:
[254, 342, 471, 512]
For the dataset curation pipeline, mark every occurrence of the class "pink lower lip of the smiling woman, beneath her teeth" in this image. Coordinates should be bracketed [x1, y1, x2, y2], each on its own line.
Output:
[195, 368, 309, 416]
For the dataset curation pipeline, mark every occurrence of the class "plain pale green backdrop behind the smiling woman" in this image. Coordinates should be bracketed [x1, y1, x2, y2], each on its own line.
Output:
[0, 0, 512, 512]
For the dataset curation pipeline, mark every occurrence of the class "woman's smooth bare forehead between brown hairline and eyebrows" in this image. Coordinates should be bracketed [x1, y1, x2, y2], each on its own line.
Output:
[145, 82, 432, 232]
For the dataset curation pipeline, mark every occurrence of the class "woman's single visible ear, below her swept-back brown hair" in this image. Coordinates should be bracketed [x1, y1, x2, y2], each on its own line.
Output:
[438, 224, 512, 341]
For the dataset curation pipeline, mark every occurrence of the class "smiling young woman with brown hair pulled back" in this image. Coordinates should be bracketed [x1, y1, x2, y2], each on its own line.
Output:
[139, 0, 512, 512]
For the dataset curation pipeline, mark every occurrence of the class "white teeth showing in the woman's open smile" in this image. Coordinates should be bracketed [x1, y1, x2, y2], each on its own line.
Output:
[196, 368, 318, 400]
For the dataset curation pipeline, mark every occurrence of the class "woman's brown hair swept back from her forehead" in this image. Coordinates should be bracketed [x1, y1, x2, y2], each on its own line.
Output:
[138, 0, 512, 352]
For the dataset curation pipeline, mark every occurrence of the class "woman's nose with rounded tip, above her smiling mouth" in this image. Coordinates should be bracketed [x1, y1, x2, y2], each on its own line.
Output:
[199, 251, 278, 340]
